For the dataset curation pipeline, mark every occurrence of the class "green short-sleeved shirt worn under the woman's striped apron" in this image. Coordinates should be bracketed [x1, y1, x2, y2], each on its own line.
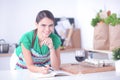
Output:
[16, 30, 61, 56]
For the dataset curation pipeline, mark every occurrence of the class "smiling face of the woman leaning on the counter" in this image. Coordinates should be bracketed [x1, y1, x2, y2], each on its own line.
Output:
[36, 17, 54, 38]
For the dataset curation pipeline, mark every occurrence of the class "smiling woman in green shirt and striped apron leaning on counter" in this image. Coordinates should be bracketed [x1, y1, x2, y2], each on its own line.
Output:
[11, 10, 61, 74]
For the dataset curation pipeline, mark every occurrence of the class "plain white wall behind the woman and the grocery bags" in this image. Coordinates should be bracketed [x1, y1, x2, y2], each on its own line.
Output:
[0, 0, 120, 48]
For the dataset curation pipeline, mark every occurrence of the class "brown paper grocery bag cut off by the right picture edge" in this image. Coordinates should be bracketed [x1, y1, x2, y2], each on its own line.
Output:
[109, 25, 120, 50]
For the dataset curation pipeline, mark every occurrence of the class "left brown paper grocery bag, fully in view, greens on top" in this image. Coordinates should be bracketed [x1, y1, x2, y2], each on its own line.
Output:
[93, 22, 109, 50]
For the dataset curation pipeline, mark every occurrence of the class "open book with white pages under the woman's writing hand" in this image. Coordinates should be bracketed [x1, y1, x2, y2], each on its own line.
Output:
[32, 70, 72, 78]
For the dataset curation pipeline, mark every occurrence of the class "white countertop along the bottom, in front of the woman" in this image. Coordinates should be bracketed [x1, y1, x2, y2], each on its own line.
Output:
[0, 70, 120, 80]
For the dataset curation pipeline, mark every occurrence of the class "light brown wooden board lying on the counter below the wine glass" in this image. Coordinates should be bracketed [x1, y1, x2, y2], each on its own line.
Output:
[61, 63, 115, 74]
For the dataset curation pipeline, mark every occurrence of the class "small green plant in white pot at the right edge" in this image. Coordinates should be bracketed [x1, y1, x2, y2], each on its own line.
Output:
[112, 47, 120, 72]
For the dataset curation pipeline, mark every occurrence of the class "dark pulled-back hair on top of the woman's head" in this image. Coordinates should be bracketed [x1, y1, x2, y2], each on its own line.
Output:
[36, 10, 55, 23]
